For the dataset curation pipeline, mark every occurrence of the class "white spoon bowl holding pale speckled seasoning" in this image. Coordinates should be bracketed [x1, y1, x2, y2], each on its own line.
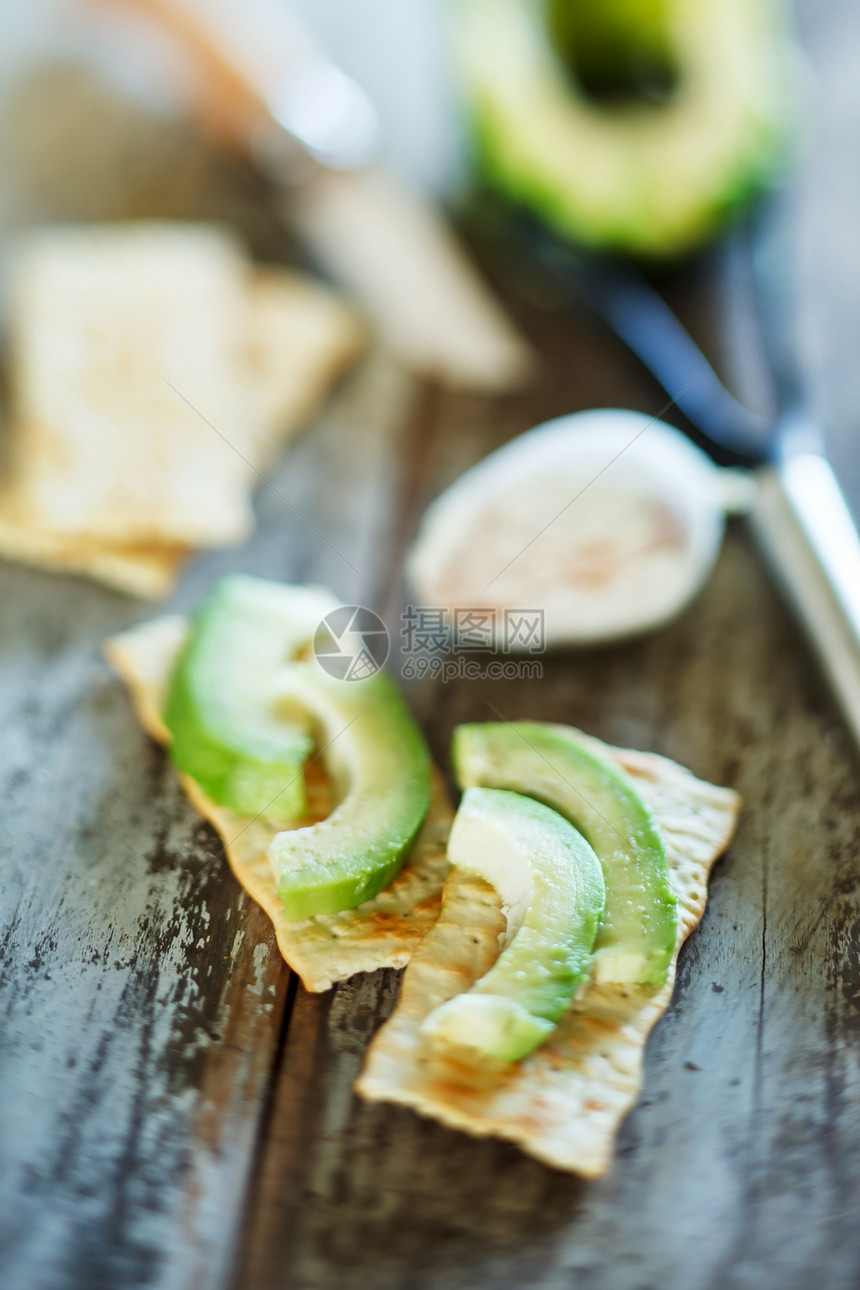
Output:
[407, 409, 754, 648]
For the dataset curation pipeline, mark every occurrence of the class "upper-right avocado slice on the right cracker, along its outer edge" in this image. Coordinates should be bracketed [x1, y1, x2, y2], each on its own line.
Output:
[453, 721, 678, 986]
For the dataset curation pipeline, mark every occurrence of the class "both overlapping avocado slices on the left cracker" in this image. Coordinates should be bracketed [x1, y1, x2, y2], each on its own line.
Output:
[165, 577, 431, 918]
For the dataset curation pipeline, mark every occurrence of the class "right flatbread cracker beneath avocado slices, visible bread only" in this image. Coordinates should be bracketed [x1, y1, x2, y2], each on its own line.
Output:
[356, 740, 740, 1178]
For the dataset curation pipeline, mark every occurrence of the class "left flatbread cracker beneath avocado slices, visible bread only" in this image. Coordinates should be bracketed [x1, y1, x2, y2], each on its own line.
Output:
[104, 617, 453, 991]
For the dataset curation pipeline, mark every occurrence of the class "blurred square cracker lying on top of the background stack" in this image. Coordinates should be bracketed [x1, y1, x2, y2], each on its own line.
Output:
[10, 222, 263, 547]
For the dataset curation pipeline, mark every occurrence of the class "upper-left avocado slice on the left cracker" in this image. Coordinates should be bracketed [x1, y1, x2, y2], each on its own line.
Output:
[164, 575, 337, 822]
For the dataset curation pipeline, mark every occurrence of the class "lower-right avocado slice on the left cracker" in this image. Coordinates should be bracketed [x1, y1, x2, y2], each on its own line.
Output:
[269, 659, 431, 918]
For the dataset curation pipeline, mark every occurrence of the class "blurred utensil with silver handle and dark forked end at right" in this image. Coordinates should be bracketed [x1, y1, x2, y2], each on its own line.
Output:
[527, 195, 860, 746]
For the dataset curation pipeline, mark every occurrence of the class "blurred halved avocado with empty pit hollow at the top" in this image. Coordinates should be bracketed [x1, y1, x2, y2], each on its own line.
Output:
[454, 0, 793, 258]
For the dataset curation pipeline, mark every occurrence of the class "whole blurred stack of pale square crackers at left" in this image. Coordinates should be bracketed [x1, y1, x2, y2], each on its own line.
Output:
[0, 223, 362, 597]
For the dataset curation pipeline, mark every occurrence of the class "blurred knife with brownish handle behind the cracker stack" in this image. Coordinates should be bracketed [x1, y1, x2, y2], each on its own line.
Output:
[90, 0, 536, 392]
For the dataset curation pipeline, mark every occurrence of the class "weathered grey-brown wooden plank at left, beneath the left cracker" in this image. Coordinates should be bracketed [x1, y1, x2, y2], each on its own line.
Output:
[0, 350, 410, 1287]
